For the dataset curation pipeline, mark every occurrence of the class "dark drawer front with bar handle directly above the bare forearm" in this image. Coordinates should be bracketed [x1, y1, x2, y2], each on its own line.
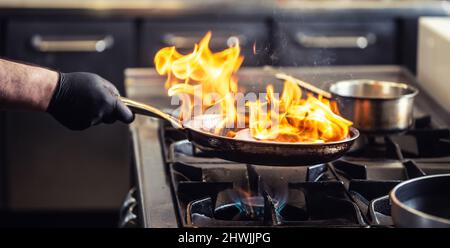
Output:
[6, 21, 134, 92]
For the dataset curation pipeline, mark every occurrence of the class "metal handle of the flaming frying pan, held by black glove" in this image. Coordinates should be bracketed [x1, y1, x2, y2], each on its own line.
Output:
[119, 97, 184, 129]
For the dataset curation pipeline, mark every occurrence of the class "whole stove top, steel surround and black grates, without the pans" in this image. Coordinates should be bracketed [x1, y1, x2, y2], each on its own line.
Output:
[125, 66, 450, 227]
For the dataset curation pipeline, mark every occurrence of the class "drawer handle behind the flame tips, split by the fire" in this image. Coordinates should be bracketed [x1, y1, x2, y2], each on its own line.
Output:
[162, 34, 247, 49]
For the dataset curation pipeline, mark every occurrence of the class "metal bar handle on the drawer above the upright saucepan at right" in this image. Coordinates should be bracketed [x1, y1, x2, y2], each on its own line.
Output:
[296, 33, 376, 49]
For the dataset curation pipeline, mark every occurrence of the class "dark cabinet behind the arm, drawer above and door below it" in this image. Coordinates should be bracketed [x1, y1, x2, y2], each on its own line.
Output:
[5, 20, 135, 209]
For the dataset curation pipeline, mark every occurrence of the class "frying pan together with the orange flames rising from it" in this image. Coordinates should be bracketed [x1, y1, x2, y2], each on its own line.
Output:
[122, 33, 359, 166]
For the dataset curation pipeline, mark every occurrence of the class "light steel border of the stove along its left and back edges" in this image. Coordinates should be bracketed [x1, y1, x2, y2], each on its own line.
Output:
[125, 66, 450, 227]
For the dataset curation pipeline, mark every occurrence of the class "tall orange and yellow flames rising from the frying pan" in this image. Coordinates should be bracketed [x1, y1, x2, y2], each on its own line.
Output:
[154, 32, 352, 142]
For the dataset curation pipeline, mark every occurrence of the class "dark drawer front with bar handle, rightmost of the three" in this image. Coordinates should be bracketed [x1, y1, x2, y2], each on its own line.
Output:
[275, 21, 396, 66]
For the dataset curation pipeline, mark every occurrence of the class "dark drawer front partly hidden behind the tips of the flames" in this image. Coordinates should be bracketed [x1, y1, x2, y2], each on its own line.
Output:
[139, 22, 269, 66]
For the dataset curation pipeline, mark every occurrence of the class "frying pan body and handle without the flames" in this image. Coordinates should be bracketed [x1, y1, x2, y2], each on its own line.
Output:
[121, 97, 359, 166]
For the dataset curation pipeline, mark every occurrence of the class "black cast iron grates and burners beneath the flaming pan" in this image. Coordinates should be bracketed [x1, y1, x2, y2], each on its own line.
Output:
[160, 111, 450, 227]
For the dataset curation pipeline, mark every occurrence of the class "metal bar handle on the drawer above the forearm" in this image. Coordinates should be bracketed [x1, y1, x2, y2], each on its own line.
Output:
[31, 35, 114, 53]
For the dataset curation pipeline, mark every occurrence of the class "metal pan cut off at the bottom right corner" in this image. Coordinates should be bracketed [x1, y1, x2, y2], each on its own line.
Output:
[389, 174, 450, 228]
